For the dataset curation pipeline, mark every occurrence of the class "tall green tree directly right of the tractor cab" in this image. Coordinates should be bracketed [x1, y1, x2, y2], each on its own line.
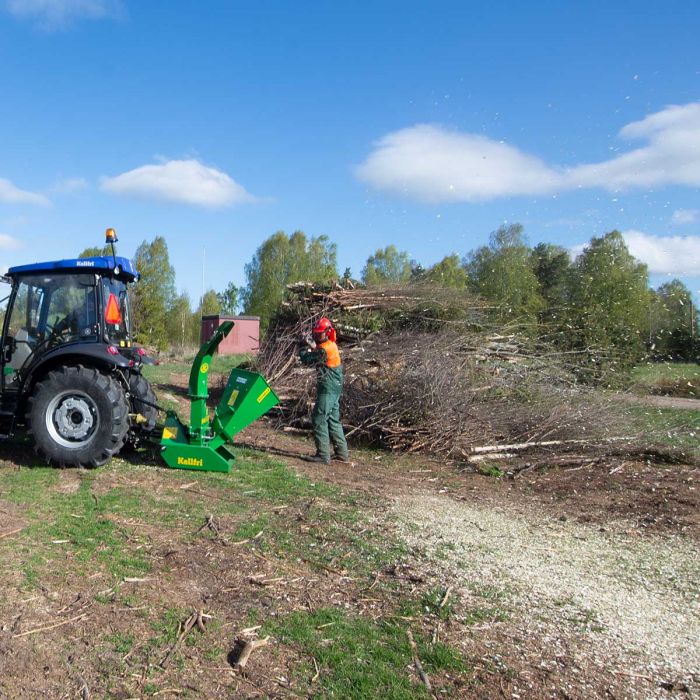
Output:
[131, 236, 177, 350]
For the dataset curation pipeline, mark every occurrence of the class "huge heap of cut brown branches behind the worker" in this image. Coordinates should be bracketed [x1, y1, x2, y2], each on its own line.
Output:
[259, 283, 620, 460]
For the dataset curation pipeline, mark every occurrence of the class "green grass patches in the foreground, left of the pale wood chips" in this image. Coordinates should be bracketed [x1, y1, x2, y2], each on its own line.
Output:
[0, 449, 468, 698]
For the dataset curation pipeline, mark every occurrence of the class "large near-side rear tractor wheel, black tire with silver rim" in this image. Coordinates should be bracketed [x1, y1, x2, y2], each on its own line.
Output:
[28, 365, 129, 467]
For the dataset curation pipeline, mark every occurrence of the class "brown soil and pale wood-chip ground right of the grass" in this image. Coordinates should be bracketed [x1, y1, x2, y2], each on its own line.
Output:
[246, 424, 700, 698]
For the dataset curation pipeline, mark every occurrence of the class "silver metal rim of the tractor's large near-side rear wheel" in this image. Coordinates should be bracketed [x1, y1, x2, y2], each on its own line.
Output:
[46, 391, 100, 449]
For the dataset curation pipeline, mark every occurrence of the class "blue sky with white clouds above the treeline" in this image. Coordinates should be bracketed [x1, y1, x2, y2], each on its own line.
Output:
[0, 0, 700, 299]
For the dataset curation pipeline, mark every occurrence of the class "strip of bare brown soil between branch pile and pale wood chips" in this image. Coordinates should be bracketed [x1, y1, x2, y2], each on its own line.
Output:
[240, 421, 700, 538]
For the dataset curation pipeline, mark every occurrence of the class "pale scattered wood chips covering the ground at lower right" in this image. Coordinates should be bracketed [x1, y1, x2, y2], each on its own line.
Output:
[394, 495, 700, 698]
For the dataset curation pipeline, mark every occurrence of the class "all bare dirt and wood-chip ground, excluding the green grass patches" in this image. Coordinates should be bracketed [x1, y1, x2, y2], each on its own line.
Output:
[0, 410, 700, 700]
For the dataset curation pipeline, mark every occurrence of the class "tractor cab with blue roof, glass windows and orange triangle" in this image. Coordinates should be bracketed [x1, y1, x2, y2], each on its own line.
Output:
[0, 257, 137, 390]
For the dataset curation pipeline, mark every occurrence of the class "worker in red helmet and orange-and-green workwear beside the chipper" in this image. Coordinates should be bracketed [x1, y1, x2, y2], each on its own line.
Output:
[299, 317, 349, 464]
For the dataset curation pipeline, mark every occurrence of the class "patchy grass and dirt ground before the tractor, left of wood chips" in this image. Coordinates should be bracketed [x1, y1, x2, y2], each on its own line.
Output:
[0, 449, 468, 700]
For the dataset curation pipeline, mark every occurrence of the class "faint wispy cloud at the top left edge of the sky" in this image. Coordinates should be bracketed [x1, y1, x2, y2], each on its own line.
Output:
[5, 0, 124, 31]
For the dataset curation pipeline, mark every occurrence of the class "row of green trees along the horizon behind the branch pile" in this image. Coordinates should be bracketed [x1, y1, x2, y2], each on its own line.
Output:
[91, 224, 700, 371]
